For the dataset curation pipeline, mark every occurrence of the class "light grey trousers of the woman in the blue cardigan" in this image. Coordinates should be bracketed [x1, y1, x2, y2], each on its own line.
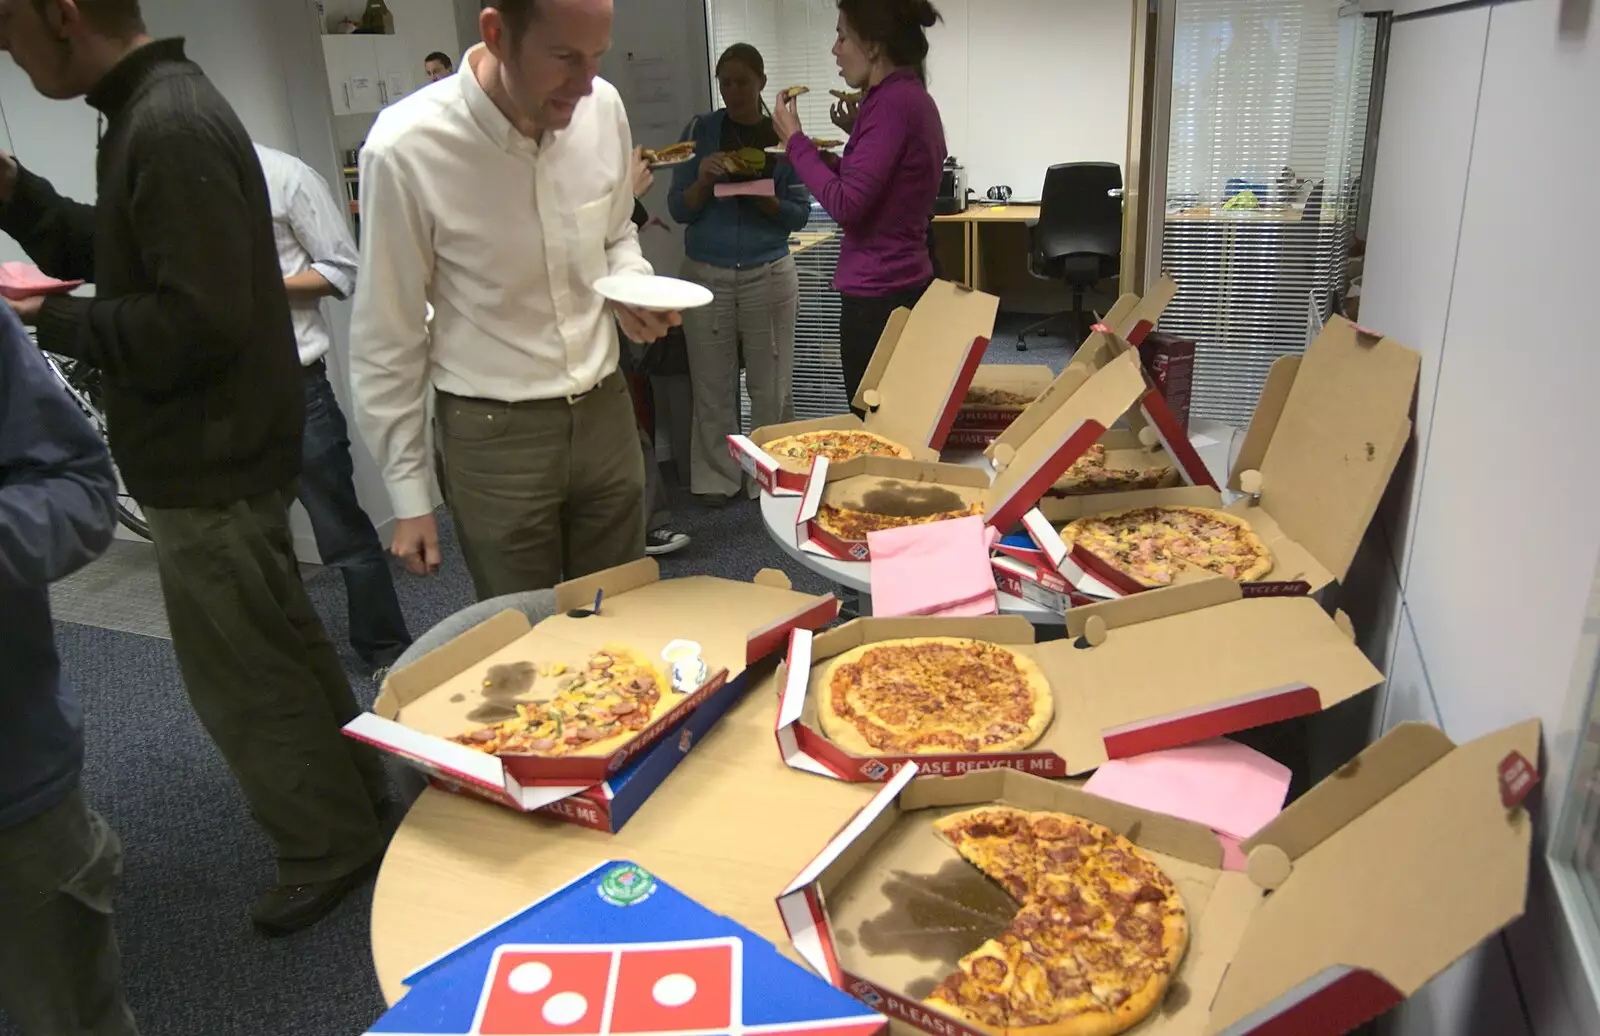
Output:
[683, 256, 800, 496]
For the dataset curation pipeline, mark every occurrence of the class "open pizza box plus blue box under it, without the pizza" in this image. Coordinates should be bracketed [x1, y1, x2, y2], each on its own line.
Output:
[344, 558, 838, 833]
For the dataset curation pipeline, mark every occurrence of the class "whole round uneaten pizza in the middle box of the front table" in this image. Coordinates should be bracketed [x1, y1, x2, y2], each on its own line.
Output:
[819, 636, 1056, 756]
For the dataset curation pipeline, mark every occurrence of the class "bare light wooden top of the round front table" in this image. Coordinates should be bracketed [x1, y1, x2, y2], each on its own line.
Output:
[373, 667, 877, 1004]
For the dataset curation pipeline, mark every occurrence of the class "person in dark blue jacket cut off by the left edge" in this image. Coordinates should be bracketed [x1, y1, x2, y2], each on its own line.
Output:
[0, 307, 138, 1036]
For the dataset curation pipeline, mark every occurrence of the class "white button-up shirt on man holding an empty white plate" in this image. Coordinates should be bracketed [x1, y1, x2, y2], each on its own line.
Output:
[350, 46, 651, 518]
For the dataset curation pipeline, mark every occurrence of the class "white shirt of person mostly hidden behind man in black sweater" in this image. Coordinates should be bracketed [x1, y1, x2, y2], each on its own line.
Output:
[256, 144, 360, 366]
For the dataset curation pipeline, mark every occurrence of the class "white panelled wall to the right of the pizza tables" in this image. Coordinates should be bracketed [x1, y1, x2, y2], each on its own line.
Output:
[1362, 0, 1600, 1036]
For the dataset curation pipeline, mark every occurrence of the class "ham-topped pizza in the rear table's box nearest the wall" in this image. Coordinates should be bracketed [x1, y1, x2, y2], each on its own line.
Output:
[1061, 507, 1272, 587]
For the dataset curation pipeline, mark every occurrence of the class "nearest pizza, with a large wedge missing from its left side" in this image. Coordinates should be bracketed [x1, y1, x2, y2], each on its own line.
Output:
[923, 806, 1189, 1036]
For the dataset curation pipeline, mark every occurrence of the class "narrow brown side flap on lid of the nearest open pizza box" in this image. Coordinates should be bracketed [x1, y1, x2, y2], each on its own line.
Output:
[1243, 723, 1456, 860]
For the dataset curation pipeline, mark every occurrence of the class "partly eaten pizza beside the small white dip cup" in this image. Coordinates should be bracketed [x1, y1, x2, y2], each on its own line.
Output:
[451, 648, 682, 756]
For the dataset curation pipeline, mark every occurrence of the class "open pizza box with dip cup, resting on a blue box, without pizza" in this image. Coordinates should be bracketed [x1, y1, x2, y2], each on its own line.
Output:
[344, 558, 838, 812]
